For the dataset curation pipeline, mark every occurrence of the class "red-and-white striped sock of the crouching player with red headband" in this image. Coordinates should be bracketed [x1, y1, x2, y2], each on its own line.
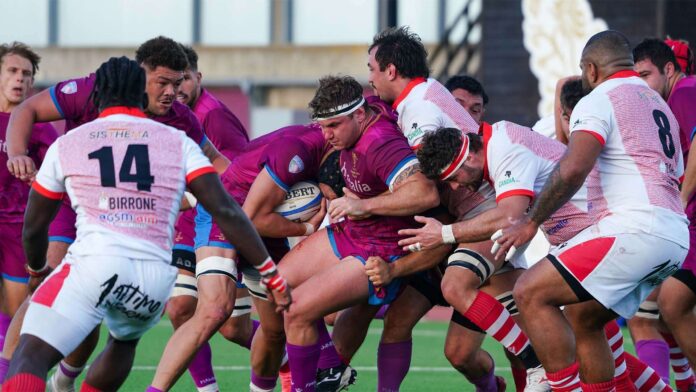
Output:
[464, 291, 529, 355]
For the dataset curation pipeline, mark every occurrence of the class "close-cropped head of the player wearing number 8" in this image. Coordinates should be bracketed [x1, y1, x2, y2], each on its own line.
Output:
[580, 30, 633, 90]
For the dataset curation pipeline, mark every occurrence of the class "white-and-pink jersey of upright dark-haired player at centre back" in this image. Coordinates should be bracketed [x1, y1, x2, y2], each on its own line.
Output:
[392, 78, 479, 149]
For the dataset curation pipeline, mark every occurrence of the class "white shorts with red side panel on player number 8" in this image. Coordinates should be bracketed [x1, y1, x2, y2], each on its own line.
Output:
[548, 216, 688, 318]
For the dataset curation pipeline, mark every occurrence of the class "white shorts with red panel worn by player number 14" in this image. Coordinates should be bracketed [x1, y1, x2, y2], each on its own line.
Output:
[21, 254, 177, 356]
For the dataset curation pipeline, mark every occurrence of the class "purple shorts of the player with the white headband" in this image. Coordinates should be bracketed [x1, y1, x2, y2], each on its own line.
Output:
[326, 220, 406, 305]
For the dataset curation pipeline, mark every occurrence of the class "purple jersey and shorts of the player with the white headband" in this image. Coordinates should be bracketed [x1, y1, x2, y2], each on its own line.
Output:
[330, 100, 418, 260]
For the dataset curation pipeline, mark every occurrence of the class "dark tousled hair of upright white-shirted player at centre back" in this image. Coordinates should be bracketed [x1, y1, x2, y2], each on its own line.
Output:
[367, 26, 430, 78]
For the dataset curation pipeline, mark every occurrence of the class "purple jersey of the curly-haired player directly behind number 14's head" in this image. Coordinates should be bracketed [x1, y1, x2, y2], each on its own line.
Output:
[49, 74, 207, 146]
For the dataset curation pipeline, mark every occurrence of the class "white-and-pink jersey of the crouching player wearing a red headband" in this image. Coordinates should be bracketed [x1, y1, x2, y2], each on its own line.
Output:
[483, 121, 593, 245]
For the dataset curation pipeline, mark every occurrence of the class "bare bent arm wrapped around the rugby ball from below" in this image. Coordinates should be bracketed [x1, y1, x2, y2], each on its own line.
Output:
[242, 170, 326, 238]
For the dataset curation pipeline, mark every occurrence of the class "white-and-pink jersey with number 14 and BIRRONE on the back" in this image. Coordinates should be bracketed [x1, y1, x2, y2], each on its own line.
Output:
[33, 107, 215, 263]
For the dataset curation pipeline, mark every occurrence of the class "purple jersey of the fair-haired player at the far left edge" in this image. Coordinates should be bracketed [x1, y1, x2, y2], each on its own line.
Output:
[0, 112, 58, 224]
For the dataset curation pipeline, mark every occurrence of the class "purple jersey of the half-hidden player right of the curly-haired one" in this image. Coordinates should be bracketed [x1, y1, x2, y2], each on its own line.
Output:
[193, 89, 249, 160]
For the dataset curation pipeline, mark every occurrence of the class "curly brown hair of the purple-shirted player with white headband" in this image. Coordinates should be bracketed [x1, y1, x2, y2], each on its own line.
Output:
[308, 75, 367, 119]
